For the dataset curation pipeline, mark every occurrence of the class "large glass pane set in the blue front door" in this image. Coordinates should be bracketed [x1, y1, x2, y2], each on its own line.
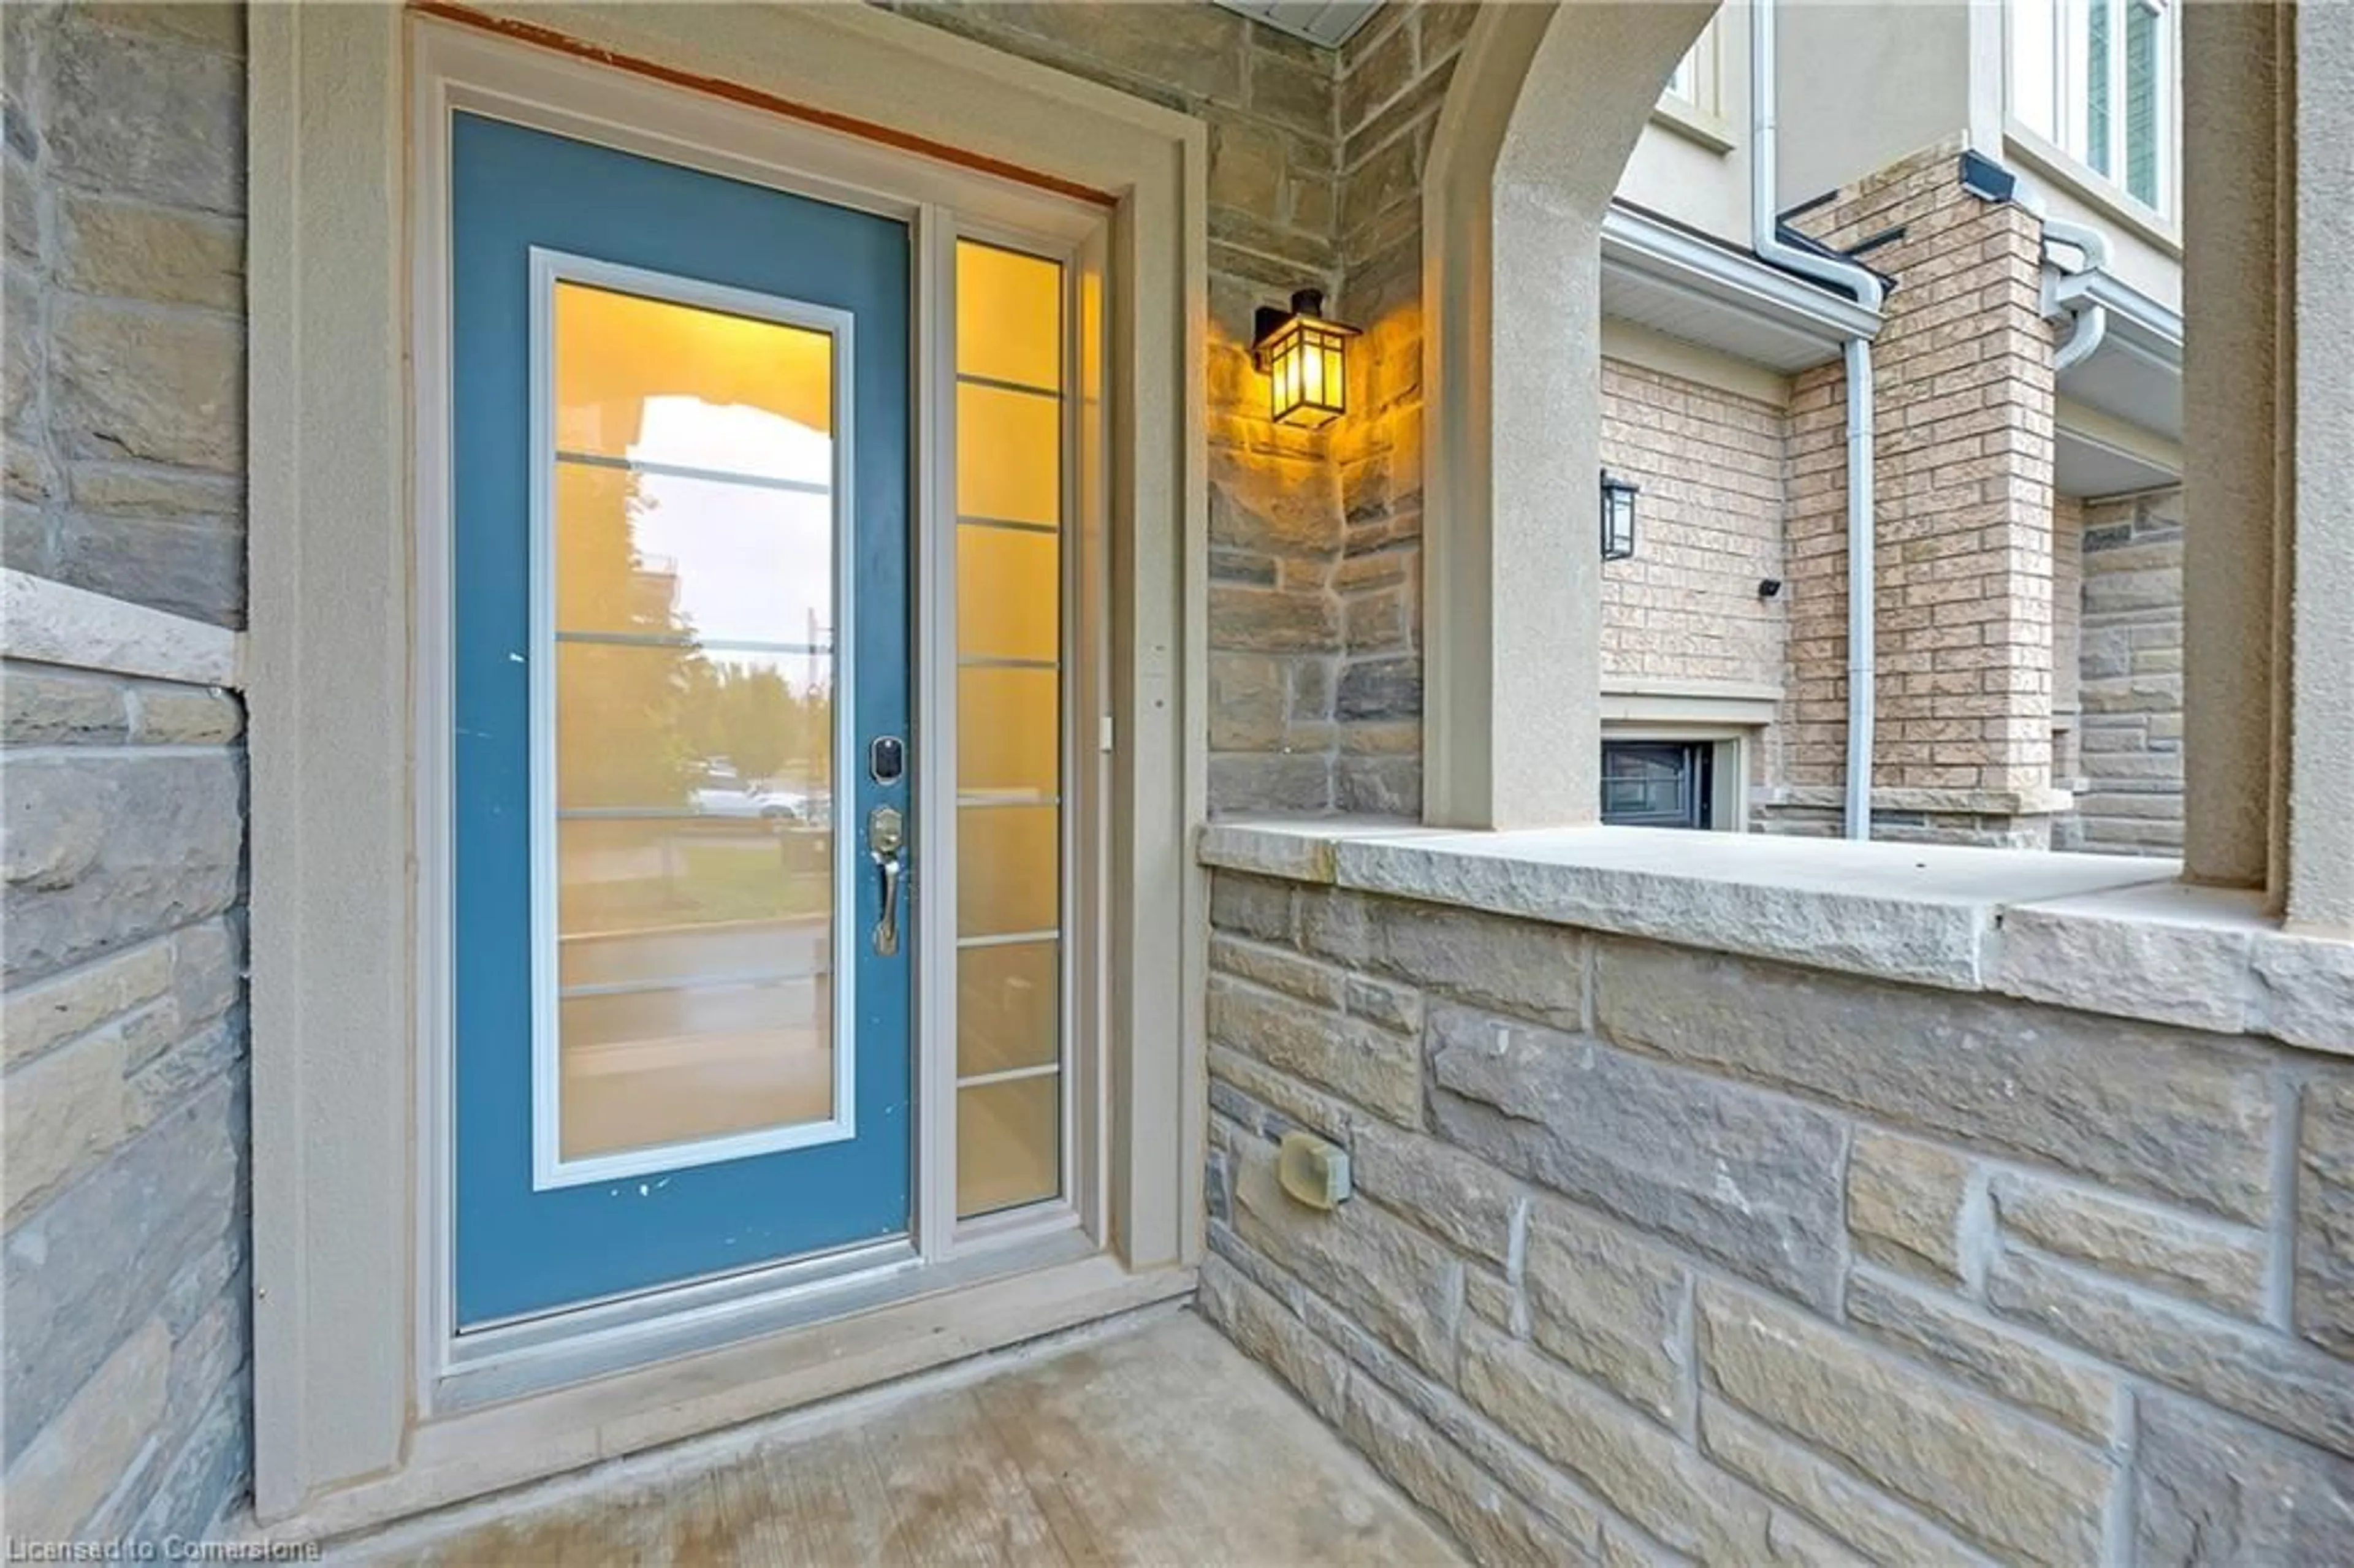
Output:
[549, 280, 836, 1161]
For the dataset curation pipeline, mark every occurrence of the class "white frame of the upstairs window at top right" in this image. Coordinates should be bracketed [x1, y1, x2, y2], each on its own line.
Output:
[2003, 0, 2182, 220]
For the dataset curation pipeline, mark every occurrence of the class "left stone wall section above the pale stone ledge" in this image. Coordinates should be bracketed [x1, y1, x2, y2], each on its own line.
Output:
[5, 5, 245, 626]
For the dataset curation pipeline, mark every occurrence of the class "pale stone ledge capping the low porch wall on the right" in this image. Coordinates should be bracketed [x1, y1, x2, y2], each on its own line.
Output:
[1200, 817, 2354, 1055]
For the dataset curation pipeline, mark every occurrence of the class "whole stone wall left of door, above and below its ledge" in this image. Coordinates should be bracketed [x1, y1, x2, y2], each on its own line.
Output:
[0, 5, 249, 1542]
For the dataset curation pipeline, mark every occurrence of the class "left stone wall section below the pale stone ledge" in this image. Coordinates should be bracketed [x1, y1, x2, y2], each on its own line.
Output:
[0, 661, 249, 1540]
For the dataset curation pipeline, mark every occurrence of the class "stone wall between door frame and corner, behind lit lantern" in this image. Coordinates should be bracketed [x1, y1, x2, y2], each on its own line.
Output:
[892, 0, 1355, 812]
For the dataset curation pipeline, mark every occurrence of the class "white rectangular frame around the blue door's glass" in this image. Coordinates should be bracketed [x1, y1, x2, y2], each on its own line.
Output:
[525, 245, 864, 1191]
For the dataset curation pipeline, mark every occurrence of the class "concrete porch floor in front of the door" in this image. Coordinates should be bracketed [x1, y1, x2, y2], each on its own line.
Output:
[330, 1311, 1462, 1568]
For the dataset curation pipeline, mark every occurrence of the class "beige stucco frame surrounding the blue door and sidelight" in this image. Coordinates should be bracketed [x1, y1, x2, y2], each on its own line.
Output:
[249, 7, 1205, 1531]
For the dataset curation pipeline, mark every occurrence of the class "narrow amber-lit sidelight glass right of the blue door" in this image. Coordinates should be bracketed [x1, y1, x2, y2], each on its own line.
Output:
[956, 240, 1068, 1215]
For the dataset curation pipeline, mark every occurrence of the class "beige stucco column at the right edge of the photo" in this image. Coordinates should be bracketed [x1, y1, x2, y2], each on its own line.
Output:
[2182, 5, 2354, 937]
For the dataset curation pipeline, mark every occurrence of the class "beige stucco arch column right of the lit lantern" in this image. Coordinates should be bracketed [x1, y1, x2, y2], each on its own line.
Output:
[1422, 0, 1716, 829]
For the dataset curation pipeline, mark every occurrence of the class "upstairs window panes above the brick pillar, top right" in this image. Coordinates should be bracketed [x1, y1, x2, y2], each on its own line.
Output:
[2010, 0, 2177, 212]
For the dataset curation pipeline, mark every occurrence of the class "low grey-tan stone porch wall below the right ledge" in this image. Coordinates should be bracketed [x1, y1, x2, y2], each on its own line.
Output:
[1203, 871, 2354, 1568]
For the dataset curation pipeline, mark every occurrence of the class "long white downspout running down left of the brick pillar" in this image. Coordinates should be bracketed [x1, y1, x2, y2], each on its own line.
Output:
[1749, 0, 1886, 838]
